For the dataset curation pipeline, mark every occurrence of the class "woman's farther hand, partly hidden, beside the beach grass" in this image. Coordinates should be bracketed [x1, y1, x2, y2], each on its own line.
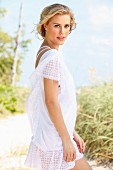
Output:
[73, 131, 86, 153]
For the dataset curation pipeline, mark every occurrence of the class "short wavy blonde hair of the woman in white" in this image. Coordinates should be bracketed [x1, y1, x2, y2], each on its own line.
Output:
[37, 4, 76, 38]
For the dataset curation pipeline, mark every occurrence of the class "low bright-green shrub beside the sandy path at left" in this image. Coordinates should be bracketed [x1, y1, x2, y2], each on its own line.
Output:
[0, 85, 29, 114]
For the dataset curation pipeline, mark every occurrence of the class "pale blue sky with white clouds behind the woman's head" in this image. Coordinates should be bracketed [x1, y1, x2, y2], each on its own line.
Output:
[0, 0, 113, 86]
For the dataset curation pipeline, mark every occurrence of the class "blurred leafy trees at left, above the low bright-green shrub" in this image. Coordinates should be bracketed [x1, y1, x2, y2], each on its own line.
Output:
[0, 5, 30, 85]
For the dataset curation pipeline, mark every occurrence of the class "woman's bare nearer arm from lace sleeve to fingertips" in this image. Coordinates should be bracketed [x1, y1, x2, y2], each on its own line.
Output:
[44, 78, 76, 162]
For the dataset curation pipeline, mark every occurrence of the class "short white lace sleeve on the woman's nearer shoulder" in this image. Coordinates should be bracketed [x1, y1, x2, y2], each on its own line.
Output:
[43, 56, 60, 82]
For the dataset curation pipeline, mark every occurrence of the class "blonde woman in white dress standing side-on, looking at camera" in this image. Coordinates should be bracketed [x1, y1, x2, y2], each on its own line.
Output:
[25, 4, 91, 170]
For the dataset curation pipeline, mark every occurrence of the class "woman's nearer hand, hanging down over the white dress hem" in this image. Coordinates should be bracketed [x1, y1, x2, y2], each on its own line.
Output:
[63, 139, 76, 162]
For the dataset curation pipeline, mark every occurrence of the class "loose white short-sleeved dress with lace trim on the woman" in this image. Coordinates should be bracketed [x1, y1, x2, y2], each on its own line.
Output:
[25, 49, 83, 170]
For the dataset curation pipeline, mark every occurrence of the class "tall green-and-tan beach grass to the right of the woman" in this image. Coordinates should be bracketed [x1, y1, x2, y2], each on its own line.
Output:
[76, 83, 113, 165]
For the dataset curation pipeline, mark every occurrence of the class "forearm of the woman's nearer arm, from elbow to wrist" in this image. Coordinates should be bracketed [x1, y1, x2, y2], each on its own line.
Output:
[46, 102, 70, 142]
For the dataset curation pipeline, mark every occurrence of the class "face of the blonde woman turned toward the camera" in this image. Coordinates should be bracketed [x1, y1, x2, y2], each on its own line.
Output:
[44, 14, 70, 47]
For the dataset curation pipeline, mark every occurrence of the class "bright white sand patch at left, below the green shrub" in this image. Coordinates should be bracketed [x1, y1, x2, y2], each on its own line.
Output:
[0, 114, 31, 157]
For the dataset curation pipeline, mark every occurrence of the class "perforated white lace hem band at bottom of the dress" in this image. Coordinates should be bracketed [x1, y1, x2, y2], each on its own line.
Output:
[26, 143, 74, 170]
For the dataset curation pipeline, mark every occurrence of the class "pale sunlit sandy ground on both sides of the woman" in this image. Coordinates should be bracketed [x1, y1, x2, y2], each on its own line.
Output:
[0, 114, 110, 170]
